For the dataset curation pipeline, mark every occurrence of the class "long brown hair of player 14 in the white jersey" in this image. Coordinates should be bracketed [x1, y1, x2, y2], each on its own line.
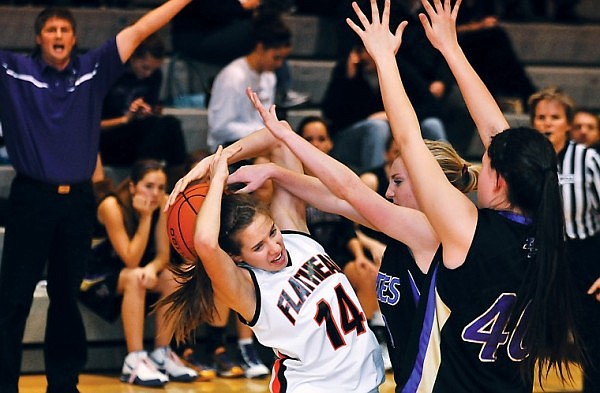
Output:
[156, 194, 269, 342]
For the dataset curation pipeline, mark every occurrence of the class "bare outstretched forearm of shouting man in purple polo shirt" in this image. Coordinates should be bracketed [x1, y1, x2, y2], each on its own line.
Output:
[117, 0, 191, 63]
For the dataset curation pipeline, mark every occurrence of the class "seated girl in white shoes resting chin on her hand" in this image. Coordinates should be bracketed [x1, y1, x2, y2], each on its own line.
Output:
[80, 160, 198, 386]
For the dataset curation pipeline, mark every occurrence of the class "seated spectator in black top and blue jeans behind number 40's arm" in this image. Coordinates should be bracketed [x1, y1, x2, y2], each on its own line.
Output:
[322, 41, 447, 173]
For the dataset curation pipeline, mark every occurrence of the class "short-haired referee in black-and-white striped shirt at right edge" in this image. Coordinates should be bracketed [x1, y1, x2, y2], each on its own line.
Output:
[529, 87, 600, 393]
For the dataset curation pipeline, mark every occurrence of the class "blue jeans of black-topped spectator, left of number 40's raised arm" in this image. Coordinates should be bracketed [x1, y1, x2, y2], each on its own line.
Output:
[331, 119, 391, 173]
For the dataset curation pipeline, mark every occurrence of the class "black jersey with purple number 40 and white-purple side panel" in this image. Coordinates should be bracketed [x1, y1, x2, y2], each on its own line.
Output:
[398, 209, 535, 393]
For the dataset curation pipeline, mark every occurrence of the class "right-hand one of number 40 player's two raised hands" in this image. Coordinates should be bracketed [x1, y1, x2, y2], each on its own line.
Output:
[419, 0, 461, 52]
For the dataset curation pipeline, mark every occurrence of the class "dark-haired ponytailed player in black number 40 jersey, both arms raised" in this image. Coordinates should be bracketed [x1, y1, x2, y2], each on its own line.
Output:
[348, 0, 579, 392]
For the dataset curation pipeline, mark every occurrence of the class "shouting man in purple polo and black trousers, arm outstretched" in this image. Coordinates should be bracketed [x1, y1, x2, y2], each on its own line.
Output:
[0, 0, 190, 393]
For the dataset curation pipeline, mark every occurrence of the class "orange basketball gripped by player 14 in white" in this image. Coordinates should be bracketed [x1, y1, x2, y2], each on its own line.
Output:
[167, 182, 209, 261]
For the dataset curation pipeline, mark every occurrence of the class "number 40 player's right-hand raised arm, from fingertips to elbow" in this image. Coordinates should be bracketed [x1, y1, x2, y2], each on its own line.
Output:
[419, 0, 509, 149]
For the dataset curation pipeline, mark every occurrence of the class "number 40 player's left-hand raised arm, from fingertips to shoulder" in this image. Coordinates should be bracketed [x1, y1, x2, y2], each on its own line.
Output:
[347, 0, 477, 268]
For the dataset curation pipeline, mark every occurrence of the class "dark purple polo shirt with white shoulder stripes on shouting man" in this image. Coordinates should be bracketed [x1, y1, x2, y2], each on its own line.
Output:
[0, 38, 124, 184]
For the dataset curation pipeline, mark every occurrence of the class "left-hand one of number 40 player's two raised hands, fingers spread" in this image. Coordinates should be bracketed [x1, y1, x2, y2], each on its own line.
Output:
[346, 0, 408, 62]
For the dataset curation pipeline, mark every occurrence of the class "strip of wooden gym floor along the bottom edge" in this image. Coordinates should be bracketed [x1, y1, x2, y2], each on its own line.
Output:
[19, 368, 581, 393]
